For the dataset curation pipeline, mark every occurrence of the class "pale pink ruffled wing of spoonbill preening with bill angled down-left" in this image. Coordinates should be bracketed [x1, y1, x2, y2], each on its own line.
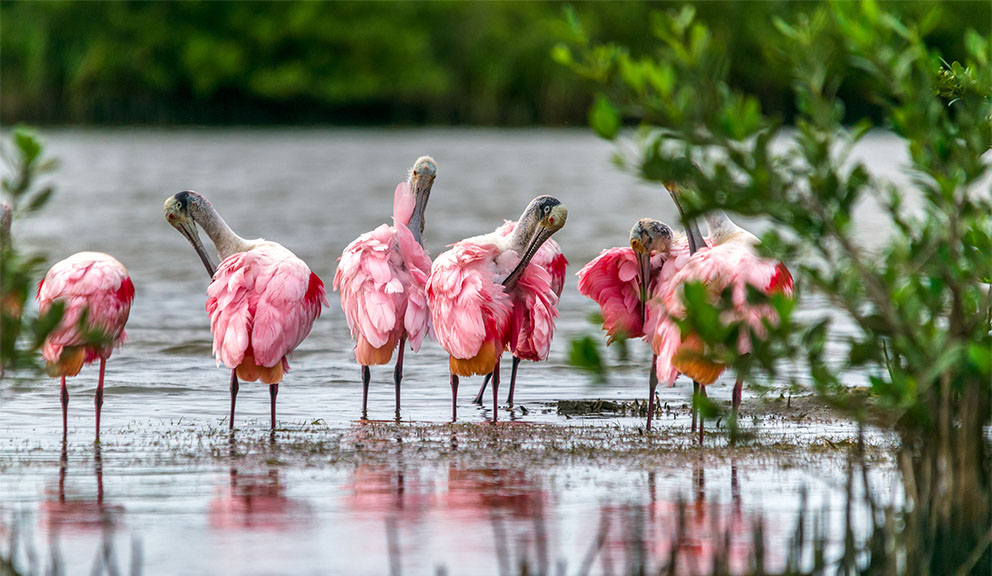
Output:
[427, 240, 512, 359]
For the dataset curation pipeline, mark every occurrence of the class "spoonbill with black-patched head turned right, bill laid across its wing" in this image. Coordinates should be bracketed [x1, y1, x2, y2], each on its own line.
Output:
[427, 196, 568, 421]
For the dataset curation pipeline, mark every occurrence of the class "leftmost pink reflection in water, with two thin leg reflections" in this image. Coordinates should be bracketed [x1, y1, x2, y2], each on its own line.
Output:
[40, 442, 124, 531]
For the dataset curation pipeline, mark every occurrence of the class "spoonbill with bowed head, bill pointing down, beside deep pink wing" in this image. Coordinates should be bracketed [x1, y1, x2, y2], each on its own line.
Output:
[576, 218, 689, 430]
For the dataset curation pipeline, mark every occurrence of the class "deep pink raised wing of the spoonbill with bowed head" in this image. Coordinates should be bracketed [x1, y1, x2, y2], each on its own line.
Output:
[576, 248, 644, 342]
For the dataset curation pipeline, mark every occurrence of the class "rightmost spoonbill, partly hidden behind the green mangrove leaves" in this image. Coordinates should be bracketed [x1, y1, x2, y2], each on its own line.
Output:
[652, 185, 793, 443]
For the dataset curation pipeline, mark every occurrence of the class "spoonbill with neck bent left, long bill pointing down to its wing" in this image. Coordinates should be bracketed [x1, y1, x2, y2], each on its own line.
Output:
[165, 190, 327, 430]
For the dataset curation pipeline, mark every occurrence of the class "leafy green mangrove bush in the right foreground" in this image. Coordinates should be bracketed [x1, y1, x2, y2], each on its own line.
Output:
[556, 1, 992, 573]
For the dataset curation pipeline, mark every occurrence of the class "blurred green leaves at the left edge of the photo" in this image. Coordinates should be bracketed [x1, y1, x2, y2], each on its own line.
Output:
[0, 128, 63, 372]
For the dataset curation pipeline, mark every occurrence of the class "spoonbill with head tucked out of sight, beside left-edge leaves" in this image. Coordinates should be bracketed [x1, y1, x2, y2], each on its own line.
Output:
[37, 252, 134, 440]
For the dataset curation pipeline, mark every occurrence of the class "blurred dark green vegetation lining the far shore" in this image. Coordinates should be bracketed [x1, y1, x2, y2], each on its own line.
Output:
[0, 0, 992, 126]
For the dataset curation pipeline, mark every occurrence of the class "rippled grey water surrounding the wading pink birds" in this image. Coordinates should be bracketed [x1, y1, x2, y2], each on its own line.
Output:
[0, 130, 903, 574]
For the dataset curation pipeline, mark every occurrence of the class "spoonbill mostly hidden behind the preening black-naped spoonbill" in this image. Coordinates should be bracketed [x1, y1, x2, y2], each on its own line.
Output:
[472, 220, 568, 406]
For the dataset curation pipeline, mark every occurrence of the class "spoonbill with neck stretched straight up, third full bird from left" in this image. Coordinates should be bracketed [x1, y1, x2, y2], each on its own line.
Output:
[334, 156, 437, 418]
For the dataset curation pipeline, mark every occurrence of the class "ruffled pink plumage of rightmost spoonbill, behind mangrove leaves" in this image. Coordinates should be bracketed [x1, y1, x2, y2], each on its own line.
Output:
[652, 241, 793, 385]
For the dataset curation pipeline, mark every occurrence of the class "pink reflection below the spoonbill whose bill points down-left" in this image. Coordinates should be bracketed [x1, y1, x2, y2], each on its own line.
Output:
[208, 468, 310, 530]
